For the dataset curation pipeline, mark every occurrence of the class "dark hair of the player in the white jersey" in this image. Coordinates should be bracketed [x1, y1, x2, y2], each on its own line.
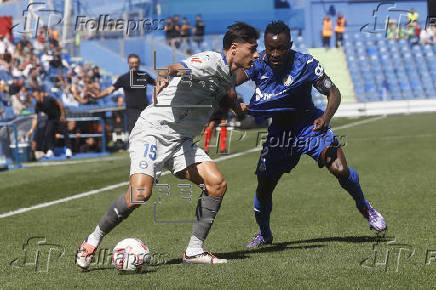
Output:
[223, 22, 259, 49]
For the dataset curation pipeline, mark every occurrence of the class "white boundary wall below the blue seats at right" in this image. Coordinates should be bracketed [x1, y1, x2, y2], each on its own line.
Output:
[335, 99, 436, 117]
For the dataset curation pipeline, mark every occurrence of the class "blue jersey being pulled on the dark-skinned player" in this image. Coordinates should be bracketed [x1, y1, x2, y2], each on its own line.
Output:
[245, 51, 324, 117]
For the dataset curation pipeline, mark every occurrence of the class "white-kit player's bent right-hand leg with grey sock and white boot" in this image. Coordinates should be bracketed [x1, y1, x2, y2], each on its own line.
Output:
[177, 161, 227, 264]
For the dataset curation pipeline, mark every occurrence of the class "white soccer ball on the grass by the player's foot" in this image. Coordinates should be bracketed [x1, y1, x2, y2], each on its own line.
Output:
[112, 238, 151, 272]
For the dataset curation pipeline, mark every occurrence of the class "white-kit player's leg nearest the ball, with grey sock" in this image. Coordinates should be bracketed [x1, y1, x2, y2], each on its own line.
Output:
[76, 174, 153, 269]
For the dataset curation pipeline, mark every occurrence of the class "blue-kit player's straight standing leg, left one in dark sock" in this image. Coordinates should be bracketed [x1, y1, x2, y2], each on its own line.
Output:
[247, 175, 280, 248]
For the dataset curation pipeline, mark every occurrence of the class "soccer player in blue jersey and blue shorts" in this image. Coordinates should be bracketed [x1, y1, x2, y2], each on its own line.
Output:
[237, 21, 387, 248]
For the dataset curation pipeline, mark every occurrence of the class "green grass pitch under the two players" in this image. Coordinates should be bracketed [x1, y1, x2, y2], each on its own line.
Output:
[0, 114, 436, 289]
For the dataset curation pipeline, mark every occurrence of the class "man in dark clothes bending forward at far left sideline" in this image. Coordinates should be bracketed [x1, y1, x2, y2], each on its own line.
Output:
[27, 88, 72, 158]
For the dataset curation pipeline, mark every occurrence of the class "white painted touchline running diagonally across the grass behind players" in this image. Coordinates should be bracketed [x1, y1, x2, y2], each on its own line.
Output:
[0, 116, 385, 219]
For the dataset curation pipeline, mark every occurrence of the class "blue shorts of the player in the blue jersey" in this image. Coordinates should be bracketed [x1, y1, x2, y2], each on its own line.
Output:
[256, 110, 339, 178]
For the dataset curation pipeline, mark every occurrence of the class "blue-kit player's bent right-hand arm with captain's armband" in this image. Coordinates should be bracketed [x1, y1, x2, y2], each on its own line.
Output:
[312, 74, 341, 131]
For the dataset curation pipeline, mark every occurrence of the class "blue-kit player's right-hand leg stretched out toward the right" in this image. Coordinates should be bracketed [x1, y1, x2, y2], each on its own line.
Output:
[320, 146, 387, 232]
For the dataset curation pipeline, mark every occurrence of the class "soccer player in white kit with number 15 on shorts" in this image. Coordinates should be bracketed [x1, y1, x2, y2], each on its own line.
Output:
[76, 22, 259, 269]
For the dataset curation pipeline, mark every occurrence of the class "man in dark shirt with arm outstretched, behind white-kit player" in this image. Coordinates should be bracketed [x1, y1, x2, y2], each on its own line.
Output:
[90, 53, 155, 134]
